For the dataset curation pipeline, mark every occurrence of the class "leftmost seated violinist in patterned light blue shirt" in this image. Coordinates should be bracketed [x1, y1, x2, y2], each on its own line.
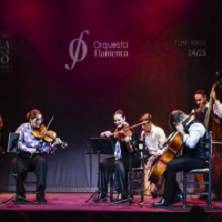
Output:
[15, 109, 61, 204]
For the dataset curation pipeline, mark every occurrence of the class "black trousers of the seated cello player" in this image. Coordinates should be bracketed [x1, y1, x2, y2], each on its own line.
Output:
[163, 157, 204, 204]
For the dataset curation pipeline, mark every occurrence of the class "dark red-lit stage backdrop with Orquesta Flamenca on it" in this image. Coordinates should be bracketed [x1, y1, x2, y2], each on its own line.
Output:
[0, 0, 222, 191]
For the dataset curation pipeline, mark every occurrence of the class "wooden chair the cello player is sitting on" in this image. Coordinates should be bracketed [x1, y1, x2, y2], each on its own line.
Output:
[182, 132, 212, 208]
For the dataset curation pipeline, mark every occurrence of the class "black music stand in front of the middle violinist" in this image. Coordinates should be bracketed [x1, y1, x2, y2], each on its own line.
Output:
[86, 137, 114, 203]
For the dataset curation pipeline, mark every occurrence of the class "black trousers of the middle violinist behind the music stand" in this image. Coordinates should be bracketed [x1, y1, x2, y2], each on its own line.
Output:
[98, 154, 140, 196]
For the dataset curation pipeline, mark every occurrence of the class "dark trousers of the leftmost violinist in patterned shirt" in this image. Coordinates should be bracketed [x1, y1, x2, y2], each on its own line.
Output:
[15, 152, 48, 197]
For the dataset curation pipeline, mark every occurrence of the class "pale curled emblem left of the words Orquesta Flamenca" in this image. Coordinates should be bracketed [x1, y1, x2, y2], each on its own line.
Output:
[65, 30, 89, 70]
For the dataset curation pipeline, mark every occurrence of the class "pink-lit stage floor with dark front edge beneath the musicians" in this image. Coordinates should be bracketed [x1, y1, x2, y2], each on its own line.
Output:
[0, 193, 222, 222]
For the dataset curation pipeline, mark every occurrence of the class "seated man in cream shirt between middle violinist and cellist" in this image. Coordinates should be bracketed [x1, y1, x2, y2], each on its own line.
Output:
[140, 113, 166, 198]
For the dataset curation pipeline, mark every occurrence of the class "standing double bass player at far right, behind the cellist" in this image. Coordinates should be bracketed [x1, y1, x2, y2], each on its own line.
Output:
[192, 89, 222, 123]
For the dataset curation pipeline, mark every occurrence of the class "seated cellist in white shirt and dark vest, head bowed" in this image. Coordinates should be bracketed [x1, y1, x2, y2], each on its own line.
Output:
[153, 110, 207, 207]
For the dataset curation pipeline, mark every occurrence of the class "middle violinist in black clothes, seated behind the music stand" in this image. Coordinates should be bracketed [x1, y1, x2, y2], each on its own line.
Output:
[94, 110, 140, 203]
